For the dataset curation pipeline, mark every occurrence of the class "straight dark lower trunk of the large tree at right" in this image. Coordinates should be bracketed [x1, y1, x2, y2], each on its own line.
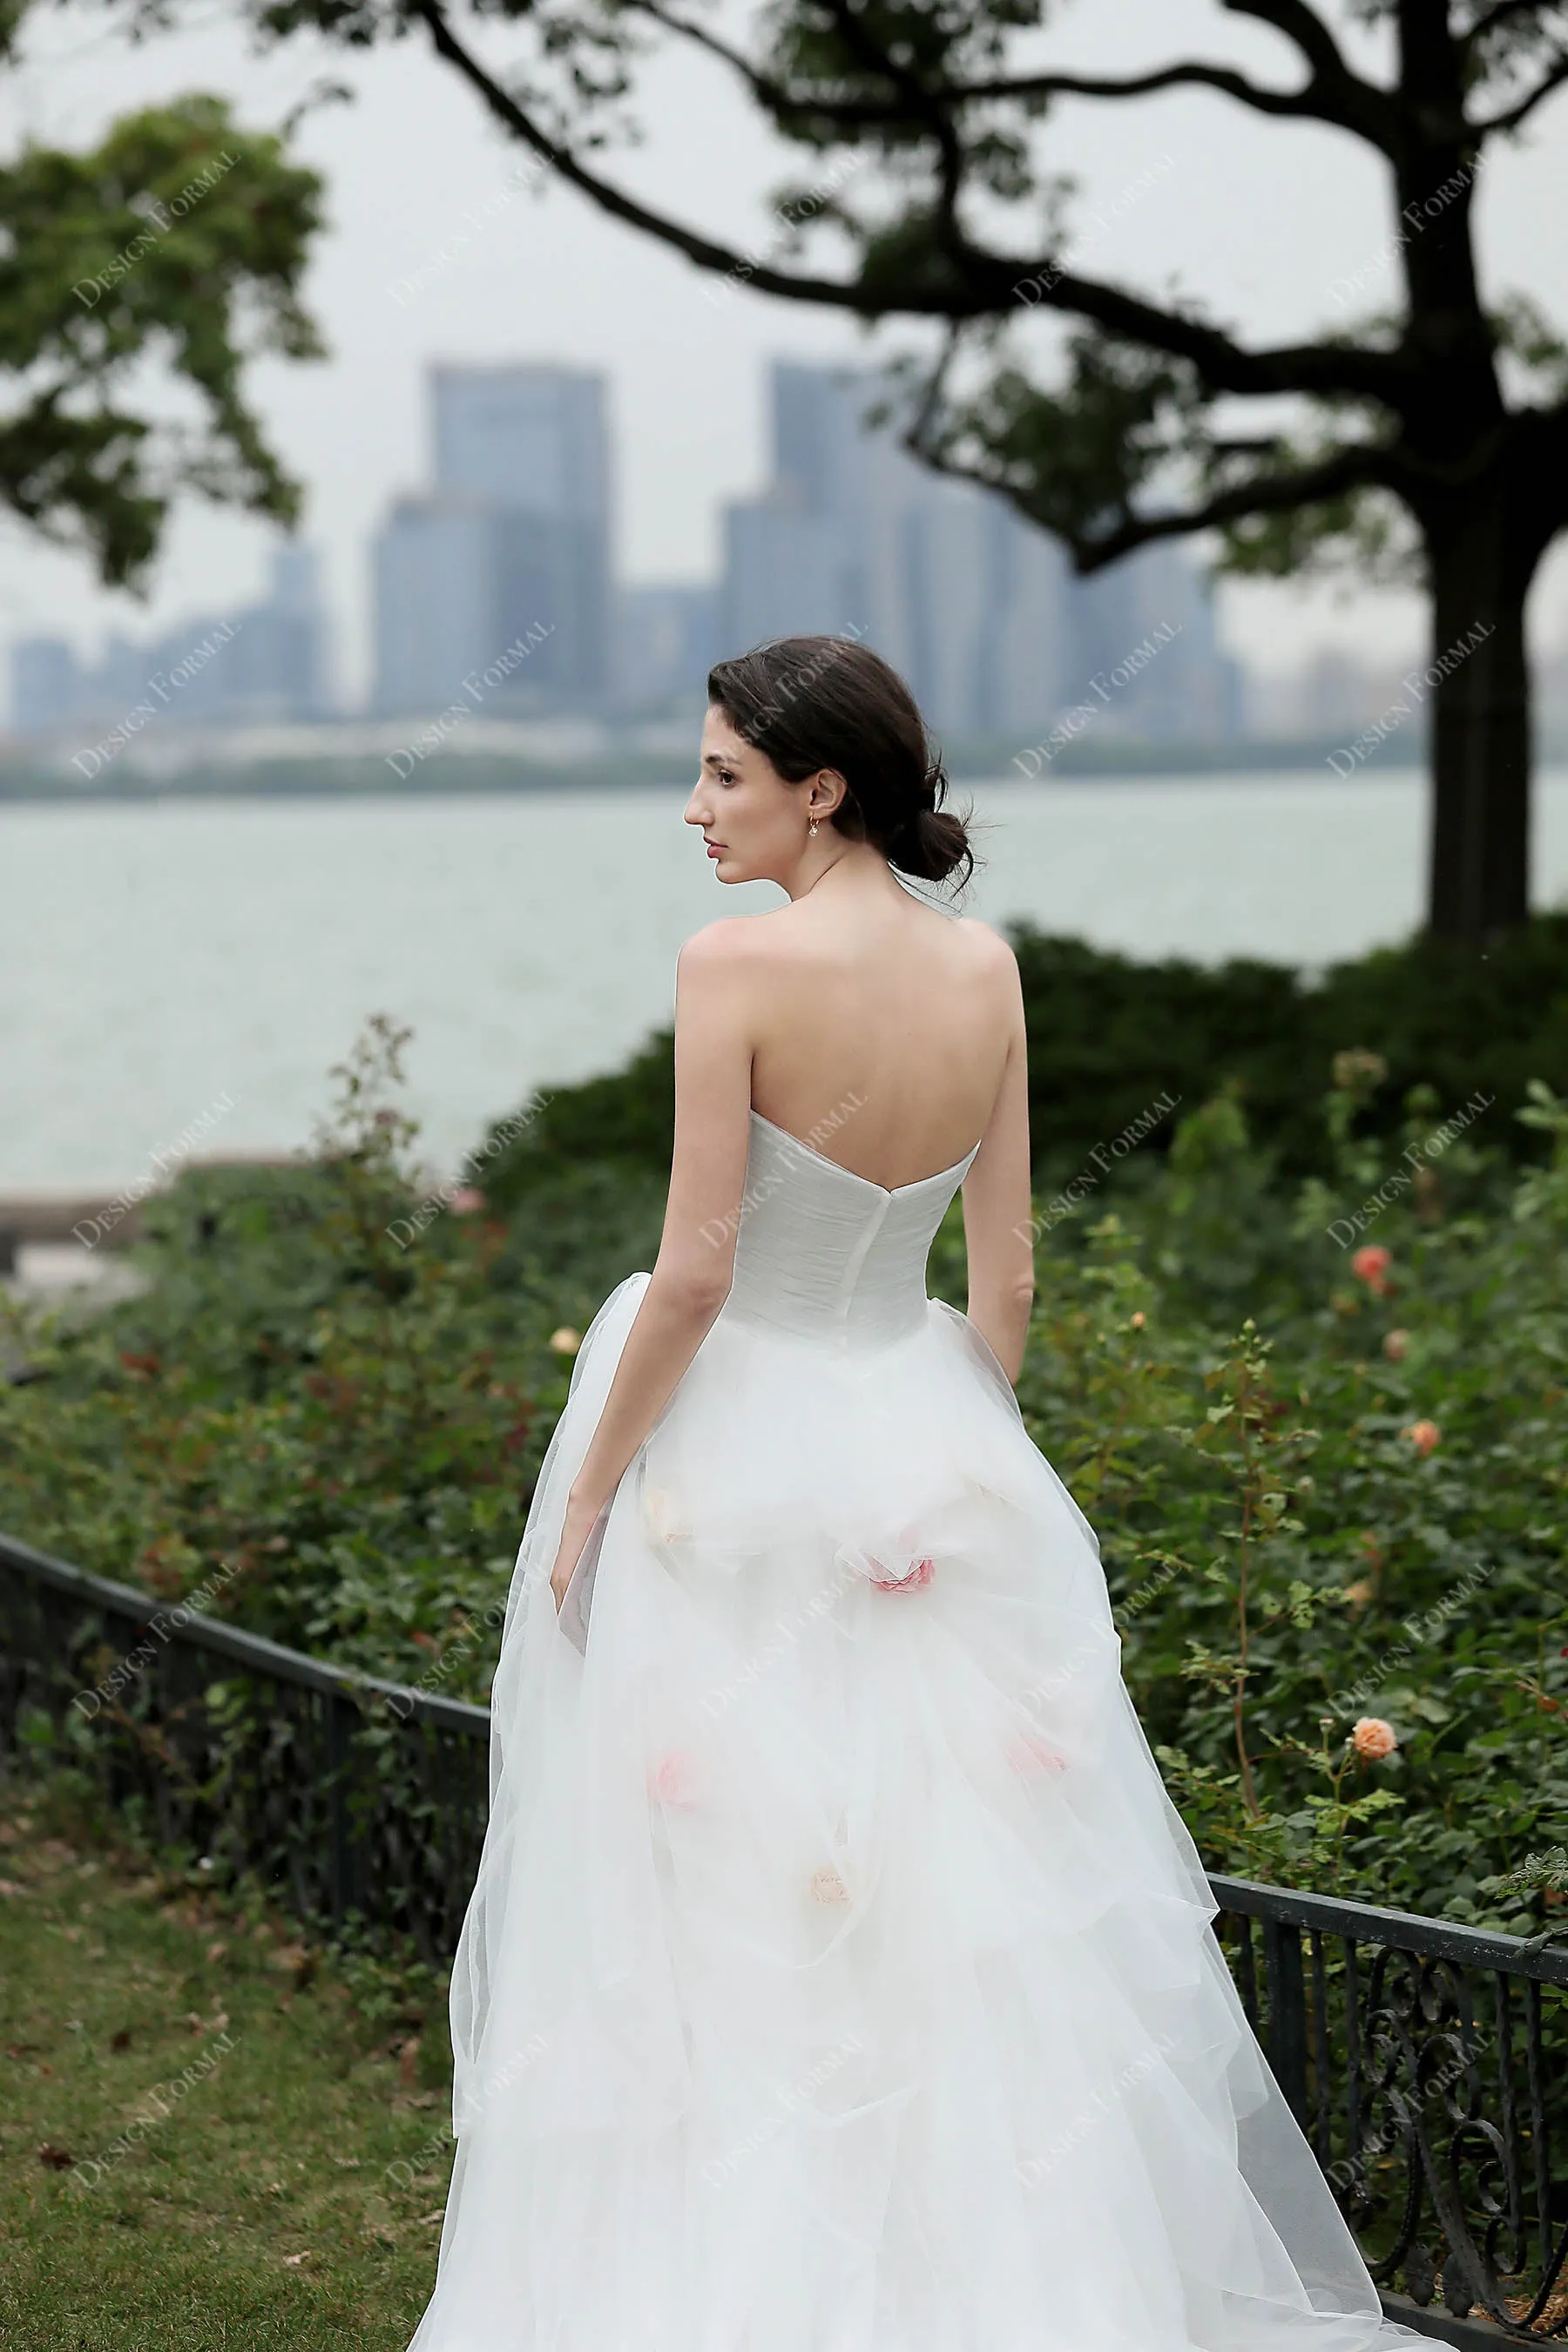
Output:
[1406, 483, 1535, 945]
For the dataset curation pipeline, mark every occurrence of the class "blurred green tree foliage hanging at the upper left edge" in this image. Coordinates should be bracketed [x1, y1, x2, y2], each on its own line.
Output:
[0, 33, 324, 588]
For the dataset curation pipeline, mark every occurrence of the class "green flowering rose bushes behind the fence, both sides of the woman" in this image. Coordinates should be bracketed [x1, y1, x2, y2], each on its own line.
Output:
[0, 1011, 1568, 1931]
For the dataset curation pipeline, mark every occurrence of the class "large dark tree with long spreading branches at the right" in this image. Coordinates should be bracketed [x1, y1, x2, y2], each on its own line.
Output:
[249, 0, 1568, 943]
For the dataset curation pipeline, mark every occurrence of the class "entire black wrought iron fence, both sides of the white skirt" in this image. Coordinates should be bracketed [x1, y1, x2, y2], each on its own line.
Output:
[0, 1536, 1568, 2352]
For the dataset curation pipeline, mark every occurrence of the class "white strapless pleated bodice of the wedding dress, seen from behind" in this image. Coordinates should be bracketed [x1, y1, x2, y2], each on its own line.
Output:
[721, 1110, 980, 1350]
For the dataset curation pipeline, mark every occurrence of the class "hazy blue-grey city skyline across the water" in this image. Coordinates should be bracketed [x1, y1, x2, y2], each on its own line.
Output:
[11, 357, 1244, 767]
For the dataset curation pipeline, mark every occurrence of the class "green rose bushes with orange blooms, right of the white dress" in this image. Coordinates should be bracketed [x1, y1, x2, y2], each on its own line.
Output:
[1020, 1077, 1568, 1933]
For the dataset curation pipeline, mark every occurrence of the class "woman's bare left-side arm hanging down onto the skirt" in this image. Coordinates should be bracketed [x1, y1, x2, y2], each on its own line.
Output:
[550, 917, 753, 1609]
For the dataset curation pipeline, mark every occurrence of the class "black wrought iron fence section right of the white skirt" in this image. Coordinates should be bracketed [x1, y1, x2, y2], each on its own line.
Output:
[1208, 1877, 1568, 2342]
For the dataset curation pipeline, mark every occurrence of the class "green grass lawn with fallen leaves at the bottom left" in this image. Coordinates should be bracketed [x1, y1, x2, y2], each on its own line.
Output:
[0, 1781, 451, 2352]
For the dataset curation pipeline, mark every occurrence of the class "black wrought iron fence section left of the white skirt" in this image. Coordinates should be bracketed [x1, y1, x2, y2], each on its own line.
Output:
[0, 1536, 489, 1964]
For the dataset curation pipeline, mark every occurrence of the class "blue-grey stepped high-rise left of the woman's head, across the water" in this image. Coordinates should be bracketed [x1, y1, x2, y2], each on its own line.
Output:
[371, 365, 612, 715]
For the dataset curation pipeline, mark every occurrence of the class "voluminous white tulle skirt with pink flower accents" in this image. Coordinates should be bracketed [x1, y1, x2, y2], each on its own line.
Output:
[411, 1274, 1408, 2352]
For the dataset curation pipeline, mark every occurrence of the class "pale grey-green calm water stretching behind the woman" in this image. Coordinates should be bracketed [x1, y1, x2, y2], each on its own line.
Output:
[0, 772, 1568, 1193]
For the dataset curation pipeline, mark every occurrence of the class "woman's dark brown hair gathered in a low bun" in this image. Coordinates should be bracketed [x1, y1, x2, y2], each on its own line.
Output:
[707, 638, 976, 889]
